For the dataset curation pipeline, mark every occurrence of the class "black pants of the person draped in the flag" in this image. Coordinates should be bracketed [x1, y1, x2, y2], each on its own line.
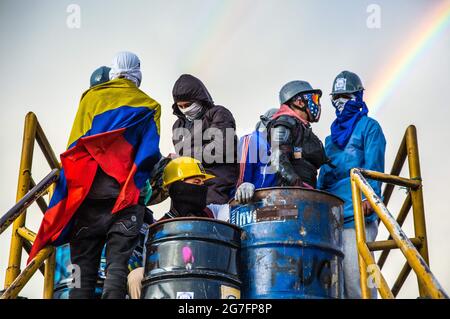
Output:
[69, 199, 145, 299]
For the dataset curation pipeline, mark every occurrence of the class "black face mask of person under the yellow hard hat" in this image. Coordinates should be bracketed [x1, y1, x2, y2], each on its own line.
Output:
[169, 181, 208, 217]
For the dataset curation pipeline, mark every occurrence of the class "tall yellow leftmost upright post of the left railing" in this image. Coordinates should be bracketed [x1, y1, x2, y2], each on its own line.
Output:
[4, 112, 37, 289]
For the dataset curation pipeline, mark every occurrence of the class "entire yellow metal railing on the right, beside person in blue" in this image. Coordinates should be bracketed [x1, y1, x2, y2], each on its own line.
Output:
[350, 126, 449, 298]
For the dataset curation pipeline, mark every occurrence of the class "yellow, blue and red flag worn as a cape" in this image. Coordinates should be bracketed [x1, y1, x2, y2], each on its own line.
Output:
[28, 79, 161, 262]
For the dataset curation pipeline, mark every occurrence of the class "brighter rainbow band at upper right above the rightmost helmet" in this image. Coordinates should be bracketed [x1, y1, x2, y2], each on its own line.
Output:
[367, 1, 450, 113]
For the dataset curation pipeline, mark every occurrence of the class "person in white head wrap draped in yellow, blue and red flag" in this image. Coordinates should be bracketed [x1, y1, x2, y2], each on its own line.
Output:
[28, 52, 161, 299]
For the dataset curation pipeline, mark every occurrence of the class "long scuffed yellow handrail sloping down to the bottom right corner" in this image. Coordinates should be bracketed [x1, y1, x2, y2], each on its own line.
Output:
[351, 169, 449, 299]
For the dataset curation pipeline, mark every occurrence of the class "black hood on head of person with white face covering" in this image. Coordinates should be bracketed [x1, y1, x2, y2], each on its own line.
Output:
[172, 74, 214, 116]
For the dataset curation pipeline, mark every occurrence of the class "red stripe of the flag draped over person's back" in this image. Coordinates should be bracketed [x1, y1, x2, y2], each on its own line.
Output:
[28, 129, 140, 262]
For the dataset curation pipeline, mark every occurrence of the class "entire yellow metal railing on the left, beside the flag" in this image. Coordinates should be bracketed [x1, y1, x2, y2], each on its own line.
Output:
[0, 112, 60, 299]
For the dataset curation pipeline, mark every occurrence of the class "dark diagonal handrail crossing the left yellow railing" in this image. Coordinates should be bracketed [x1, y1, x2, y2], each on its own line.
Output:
[0, 168, 59, 234]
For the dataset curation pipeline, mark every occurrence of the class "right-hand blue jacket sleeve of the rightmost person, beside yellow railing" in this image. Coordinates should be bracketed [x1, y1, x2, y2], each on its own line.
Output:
[363, 120, 386, 196]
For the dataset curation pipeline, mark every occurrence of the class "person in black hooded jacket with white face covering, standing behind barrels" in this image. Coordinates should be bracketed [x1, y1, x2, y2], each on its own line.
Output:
[172, 74, 239, 204]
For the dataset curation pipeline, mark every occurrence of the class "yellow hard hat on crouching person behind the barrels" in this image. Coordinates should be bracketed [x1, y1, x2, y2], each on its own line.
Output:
[163, 156, 215, 187]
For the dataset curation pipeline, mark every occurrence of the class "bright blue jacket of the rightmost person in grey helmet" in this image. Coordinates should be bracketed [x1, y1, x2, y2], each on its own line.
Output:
[317, 116, 386, 228]
